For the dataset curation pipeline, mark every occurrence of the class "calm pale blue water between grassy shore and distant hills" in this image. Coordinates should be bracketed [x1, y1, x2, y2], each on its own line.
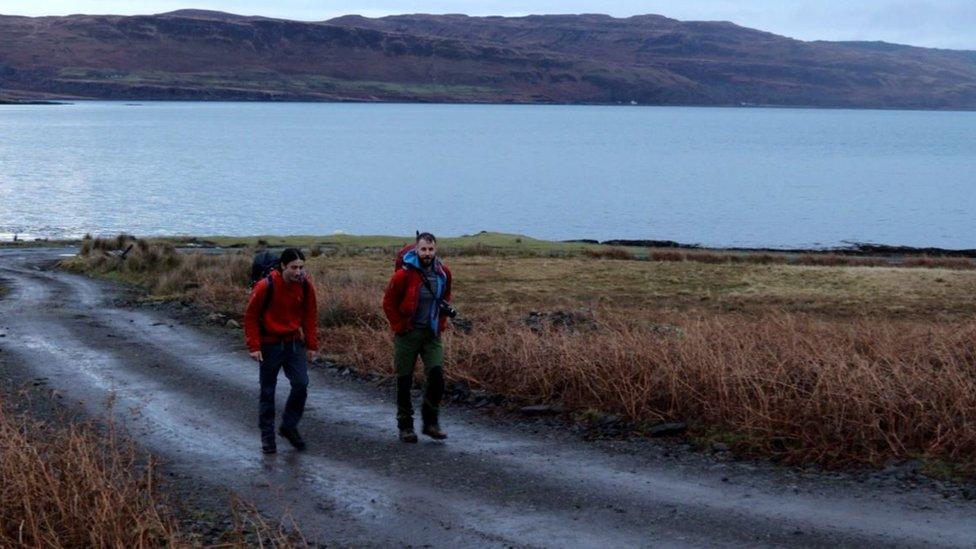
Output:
[0, 102, 976, 248]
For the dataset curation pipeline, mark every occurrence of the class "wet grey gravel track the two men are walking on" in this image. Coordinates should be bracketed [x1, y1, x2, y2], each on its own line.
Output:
[0, 249, 976, 547]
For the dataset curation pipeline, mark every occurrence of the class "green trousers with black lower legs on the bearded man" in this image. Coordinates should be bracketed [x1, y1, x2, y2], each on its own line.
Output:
[393, 328, 444, 429]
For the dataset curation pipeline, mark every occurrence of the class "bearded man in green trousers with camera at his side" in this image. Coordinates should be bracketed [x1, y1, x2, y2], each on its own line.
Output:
[383, 233, 451, 442]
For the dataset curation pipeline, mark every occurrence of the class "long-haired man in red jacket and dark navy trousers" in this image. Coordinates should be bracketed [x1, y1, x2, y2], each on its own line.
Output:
[244, 248, 318, 454]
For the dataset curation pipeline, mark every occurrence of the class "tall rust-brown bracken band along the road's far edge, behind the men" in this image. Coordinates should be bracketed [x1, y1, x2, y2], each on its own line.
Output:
[322, 302, 976, 473]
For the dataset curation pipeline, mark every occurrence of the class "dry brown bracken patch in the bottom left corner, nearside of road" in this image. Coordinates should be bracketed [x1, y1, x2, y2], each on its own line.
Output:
[0, 400, 179, 547]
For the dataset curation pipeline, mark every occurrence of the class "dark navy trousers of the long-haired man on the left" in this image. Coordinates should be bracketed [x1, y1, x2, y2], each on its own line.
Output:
[258, 341, 308, 436]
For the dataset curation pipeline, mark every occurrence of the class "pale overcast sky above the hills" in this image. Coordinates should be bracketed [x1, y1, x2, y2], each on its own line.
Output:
[0, 0, 976, 50]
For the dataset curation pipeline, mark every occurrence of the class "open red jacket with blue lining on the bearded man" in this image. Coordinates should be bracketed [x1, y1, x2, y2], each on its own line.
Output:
[383, 250, 451, 335]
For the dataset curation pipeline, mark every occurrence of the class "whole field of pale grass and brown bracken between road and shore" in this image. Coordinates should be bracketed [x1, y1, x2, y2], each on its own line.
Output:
[63, 237, 976, 474]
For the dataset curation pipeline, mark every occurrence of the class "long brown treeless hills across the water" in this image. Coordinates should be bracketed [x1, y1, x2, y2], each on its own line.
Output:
[0, 10, 976, 109]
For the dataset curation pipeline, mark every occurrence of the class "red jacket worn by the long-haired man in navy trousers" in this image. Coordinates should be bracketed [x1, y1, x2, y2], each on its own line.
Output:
[244, 270, 319, 352]
